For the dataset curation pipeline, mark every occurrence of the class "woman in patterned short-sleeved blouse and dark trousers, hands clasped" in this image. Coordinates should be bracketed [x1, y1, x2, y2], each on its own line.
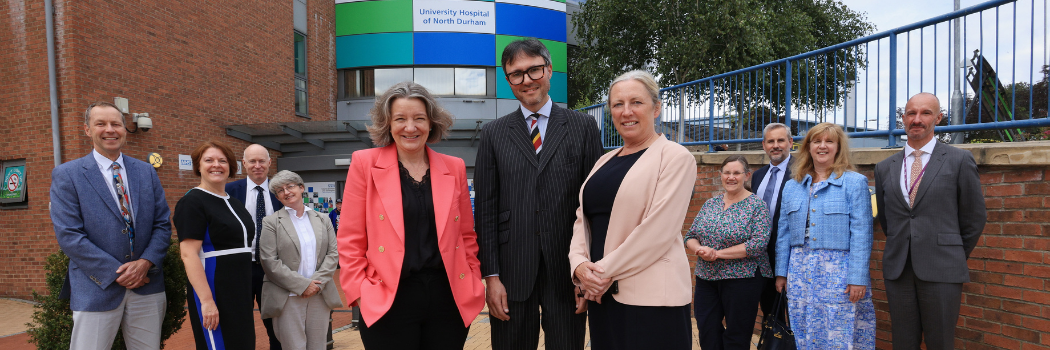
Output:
[686, 156, 773, 350]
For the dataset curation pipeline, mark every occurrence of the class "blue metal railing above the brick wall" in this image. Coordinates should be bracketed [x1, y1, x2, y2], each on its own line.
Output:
[581, 0, 1050, 149]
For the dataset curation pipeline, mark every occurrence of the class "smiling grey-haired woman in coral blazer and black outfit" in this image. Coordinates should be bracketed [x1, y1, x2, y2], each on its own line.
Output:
[338, 82, 485, 349]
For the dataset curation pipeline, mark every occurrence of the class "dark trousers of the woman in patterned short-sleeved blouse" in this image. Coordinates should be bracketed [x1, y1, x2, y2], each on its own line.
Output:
[693, 275, 765, 350]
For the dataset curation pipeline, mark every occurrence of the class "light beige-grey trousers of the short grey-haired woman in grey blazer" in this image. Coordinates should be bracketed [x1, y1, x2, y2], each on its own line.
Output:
[273, 293, 332, 350]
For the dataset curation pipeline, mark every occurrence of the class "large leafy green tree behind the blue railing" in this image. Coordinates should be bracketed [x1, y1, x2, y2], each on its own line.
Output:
[569, 0, 875, 110]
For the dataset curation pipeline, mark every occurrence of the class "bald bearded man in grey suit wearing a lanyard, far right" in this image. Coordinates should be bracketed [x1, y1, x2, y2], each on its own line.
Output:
[875, 92, 987, 350]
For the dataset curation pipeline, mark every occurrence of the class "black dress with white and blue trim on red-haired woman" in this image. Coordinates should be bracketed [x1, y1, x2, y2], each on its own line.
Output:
[171, 188, 255, 350]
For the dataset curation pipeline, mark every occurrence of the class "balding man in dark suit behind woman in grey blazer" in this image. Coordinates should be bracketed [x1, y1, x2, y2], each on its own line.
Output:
[226, 144, 285, 350]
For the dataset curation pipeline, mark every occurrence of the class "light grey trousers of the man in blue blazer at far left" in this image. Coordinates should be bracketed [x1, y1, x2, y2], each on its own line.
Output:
[69, 289, 168, 350]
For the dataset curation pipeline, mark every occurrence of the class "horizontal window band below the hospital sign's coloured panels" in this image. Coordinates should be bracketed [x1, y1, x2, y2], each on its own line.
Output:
[338, 67, 496, 100]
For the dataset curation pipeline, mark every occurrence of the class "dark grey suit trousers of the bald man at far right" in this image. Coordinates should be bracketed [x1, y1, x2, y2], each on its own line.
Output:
[886, 262, 963, 350]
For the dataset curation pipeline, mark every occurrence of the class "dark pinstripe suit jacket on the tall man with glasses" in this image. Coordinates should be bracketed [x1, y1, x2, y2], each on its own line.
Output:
[474, 104, 603, 302]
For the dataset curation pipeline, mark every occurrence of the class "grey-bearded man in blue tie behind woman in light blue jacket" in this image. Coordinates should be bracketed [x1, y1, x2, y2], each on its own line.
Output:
[751, 123, 795, 315]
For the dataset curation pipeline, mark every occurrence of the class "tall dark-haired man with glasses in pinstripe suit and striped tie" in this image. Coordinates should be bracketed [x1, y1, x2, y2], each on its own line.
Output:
[475, 39, 602, 350]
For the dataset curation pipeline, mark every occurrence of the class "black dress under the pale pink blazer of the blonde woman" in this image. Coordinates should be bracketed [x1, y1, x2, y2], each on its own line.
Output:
[582, 149, 692, 350]
